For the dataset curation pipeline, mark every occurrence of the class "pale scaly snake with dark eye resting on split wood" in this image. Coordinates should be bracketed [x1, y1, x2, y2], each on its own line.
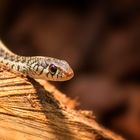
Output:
[0, 40, 74, 81]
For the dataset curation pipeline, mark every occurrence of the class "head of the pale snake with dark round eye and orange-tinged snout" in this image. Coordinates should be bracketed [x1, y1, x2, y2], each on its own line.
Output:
[32, 57, 74, 81]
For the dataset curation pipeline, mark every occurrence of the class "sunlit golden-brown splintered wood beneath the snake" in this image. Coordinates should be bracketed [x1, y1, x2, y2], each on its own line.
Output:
[0, 65, 123, 140]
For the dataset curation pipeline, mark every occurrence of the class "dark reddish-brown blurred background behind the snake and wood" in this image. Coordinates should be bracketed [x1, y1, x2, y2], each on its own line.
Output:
[0, 0, 140, 140]
